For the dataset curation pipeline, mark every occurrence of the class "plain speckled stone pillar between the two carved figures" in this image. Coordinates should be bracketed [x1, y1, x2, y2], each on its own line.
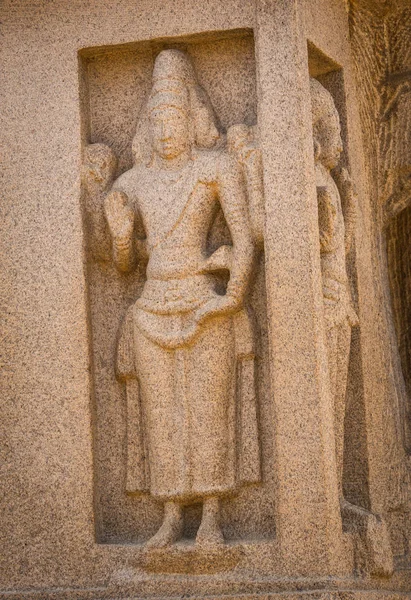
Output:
[256, 0, 344, 577]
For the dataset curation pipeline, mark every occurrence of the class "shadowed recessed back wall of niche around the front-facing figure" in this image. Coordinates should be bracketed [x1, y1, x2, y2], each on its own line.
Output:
[79, 31, 275, 544]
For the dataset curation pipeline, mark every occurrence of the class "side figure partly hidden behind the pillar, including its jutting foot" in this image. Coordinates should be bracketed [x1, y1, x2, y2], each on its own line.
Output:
[310, 78, 393, 575]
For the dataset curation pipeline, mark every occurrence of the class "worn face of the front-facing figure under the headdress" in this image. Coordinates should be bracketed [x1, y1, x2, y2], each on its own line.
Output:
[150, 106, 189, 160]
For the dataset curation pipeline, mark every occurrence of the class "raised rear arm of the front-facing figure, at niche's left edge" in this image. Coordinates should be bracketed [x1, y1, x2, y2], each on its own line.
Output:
[81, 144, 117, 262]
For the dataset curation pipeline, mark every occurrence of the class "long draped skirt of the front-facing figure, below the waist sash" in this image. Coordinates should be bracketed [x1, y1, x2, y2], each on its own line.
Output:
[116, 305, 261, 501]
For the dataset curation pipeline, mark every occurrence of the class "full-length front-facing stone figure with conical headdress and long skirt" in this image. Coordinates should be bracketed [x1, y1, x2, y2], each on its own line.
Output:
[105, 50, 260, 549]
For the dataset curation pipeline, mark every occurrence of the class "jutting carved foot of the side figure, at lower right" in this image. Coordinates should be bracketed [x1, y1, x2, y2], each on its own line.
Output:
[340, 499, 394, 577]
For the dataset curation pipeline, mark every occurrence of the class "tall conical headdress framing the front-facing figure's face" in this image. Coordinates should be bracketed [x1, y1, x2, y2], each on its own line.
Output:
[132, 49, 220, 163]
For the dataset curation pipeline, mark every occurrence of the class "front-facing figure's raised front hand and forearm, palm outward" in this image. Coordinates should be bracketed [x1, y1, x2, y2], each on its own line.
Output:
[104, 184, 135, 273]
